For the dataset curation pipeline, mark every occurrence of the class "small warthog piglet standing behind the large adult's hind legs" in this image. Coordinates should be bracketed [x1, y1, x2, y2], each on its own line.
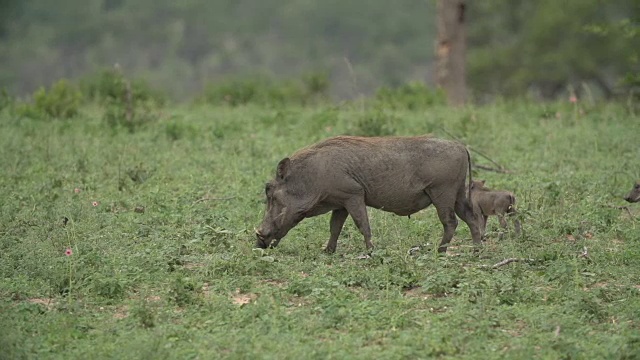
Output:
[469, 180, 521, 237]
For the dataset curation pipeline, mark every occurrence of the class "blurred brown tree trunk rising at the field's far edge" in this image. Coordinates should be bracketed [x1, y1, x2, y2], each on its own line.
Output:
[436, 0, 467, 105]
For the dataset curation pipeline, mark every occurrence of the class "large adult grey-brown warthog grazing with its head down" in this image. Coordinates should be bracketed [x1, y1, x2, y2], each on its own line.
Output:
[256, 136, 481, 253]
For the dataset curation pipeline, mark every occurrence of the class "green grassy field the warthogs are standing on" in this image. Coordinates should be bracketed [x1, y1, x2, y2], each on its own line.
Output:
[0, 103, 640, 359]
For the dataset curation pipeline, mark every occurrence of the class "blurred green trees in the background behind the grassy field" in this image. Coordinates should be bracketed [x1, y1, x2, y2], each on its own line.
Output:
[0, 0, 640, 101]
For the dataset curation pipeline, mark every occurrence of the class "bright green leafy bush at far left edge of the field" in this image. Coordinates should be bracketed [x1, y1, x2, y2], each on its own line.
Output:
[17, 79, 82, 119]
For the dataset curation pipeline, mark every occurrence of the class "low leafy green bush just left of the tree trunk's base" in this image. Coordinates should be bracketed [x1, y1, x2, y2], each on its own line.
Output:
[375, 82, 446, 110]
